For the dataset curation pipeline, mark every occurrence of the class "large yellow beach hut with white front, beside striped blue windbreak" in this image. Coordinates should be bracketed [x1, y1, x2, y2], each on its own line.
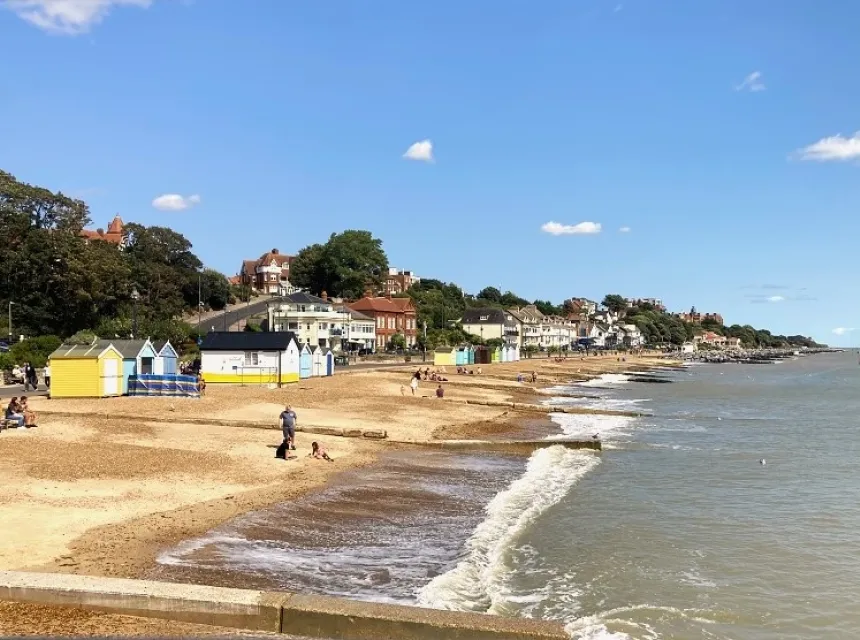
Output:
[51, 340, 123, 398]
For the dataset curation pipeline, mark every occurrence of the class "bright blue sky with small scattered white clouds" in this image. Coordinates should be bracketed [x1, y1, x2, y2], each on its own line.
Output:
[0, 0, 860, 344]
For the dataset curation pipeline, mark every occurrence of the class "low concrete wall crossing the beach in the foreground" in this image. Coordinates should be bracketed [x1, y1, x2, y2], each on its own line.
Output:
[0, 571, 568, 640]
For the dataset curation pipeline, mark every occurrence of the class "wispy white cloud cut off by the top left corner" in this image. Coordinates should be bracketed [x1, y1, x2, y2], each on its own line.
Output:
[0, 0, 153, 35]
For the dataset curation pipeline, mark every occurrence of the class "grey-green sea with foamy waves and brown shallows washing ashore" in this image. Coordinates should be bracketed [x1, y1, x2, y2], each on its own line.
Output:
[153, 352, 860, 640]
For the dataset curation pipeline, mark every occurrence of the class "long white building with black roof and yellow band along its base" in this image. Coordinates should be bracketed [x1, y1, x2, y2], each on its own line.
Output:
[200, 331, 300, 384]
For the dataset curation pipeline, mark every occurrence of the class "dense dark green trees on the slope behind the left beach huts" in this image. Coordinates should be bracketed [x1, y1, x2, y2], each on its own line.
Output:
[0, 171, 231, 339]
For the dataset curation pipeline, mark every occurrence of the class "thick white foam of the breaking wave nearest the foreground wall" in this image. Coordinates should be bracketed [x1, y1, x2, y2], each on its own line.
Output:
[418, 447, 600, 613]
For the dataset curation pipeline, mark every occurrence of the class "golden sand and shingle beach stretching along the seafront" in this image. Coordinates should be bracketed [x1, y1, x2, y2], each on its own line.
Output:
[0, 356, 668, 635]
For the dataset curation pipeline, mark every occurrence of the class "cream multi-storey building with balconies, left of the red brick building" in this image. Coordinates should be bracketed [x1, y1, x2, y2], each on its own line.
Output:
[268, 292, 350, 351]
